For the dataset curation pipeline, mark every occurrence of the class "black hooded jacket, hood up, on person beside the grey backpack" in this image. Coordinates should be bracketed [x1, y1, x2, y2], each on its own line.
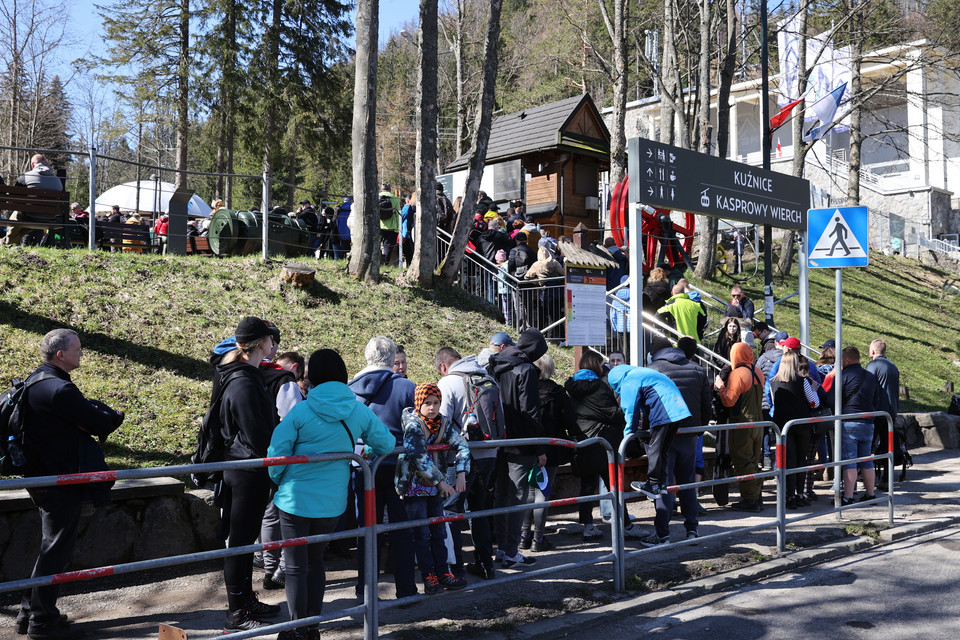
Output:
[487, 329, 547, 455]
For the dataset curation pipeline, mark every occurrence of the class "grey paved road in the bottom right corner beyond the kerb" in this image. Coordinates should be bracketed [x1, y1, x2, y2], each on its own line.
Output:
[580, 527, 960, 640]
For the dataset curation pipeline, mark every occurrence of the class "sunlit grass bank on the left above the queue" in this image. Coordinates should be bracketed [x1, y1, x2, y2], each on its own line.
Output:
[0, 248, 572, 467]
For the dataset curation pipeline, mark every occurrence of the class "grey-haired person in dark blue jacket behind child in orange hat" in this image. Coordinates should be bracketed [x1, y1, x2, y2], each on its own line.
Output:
[347, 336, 417, 598]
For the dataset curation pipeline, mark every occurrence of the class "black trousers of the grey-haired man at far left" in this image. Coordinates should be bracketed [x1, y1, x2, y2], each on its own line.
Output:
[18, 487, 83, 631]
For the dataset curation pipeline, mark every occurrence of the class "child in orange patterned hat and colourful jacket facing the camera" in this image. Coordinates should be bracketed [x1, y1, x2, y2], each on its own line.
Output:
[396, 382, 470, 595]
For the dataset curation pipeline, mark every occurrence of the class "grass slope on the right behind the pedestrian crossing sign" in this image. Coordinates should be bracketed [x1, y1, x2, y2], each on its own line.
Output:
[698, 251, 960, 411]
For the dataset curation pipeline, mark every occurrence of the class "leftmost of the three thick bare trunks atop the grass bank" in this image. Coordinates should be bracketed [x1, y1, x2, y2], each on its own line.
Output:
[348, 0, 380, 283]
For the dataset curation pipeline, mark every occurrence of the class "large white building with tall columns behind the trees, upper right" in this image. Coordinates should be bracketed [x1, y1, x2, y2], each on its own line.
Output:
[603, 40, 960, 249]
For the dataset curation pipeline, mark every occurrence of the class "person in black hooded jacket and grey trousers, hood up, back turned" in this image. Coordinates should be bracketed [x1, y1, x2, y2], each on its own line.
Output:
[487, 329, 547, 569]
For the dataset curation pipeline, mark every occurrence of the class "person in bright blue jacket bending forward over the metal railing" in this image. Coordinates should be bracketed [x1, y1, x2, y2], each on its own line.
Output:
[607, 364, 693, 499]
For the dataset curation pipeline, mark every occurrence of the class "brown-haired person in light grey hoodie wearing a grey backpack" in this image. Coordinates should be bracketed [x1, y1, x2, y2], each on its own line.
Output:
[434, 347, 503, 580]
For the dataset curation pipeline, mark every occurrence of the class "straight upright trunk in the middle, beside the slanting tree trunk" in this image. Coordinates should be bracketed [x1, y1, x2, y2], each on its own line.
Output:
[407, 0, 439, 287]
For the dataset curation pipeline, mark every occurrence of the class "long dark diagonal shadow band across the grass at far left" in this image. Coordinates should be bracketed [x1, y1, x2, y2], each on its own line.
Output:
[0, 300, 210, 382]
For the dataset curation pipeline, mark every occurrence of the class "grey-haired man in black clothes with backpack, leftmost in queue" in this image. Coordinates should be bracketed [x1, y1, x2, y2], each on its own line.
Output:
[16, 329, 123, 640]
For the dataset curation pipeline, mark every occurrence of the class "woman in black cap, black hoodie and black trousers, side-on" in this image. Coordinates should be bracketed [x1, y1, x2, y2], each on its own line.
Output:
[214, 316, 280, 631]
